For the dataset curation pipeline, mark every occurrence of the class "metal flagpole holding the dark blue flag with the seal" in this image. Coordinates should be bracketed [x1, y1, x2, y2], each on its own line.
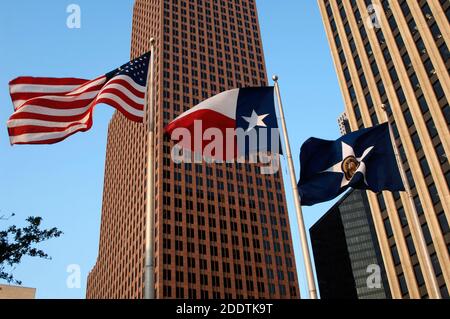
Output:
[381, 104, 441, 299]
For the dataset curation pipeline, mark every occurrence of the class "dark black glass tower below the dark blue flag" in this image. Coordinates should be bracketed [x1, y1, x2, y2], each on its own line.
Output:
[309, 190, 390, 299]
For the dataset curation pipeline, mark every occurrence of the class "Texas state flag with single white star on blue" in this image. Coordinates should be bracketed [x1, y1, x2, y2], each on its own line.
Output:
[164, 87, 282, 161]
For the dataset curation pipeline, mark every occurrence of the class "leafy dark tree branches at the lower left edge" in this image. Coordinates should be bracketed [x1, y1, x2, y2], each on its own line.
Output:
[0, 214, 62, 285]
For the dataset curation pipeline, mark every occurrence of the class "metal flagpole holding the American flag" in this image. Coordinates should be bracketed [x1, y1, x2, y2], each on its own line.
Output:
[144, 38, 155, 299]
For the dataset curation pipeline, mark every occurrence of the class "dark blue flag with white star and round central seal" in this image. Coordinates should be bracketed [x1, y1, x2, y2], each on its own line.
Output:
[298, 123, 404, 206]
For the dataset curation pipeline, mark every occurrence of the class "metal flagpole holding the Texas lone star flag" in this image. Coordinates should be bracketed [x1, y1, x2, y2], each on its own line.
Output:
[272, 75, 317, 299]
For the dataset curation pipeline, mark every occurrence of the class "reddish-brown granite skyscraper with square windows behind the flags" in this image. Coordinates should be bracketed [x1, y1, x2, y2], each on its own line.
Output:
[87, 0, 299, 299]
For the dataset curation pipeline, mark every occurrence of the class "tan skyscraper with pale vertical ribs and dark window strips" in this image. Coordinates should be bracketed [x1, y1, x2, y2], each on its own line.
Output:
[319, 0, 450, 298]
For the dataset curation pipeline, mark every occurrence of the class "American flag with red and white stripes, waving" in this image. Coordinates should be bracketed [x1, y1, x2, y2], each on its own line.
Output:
[7, 52, 150, 145]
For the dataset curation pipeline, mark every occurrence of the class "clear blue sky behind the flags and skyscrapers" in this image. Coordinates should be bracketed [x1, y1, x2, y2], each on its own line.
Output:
[0, 0, 344, 298]
